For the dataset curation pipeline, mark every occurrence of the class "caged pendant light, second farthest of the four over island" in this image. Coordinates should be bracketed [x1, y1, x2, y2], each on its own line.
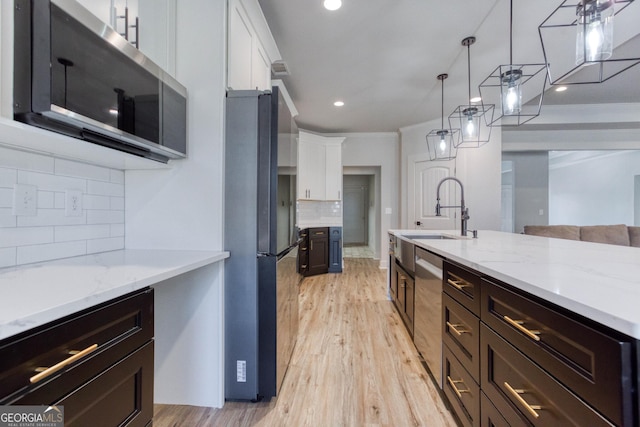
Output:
[449, 37, 495, 148]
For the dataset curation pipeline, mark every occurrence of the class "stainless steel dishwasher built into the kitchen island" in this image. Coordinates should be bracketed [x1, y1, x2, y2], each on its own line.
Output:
[413, 247, 442, 388]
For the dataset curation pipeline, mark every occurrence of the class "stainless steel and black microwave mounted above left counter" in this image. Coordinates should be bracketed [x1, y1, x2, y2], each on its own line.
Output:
[14, 0, 187, 162]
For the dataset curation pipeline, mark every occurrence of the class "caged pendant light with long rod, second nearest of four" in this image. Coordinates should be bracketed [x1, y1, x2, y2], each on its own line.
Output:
[479, 0, 547, 126]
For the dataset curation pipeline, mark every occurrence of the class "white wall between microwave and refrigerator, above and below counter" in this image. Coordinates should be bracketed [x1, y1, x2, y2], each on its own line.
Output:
[126, 0, 226, 407]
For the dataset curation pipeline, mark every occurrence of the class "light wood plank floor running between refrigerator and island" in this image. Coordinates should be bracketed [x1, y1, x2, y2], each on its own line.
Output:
[153, 258, 456, 427]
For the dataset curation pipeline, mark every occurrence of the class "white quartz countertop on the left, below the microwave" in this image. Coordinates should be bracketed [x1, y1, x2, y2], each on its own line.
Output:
[0, 249, 229, 340]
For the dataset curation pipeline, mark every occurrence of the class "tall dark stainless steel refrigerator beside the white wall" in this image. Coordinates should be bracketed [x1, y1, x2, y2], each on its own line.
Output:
[224, 87, 301, 401]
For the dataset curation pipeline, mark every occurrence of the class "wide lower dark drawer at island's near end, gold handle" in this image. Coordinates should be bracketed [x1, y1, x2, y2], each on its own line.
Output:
[480, 324, 613, 427]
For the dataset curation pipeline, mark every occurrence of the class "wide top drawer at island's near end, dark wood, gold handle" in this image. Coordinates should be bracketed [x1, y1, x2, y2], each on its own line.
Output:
[481, 280, 637, 425]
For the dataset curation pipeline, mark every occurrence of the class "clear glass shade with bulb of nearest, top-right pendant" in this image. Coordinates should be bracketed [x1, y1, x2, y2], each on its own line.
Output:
[576, 0, 614, 65]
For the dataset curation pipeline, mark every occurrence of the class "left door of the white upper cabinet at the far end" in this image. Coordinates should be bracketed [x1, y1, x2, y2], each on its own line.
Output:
[298, 138, 326, 200]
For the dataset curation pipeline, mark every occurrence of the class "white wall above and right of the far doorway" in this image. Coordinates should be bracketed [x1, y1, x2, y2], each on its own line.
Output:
[341, 133, 400, 268]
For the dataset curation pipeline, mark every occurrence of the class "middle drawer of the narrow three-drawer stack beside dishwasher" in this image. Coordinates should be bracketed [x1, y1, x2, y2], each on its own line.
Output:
[442, 293, 480, 383]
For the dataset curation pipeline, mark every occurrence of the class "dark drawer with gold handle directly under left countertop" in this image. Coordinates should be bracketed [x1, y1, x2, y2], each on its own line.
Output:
[0, 289, 153, 404]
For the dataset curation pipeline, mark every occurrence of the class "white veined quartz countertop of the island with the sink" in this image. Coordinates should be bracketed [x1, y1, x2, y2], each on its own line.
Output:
[390, 230, 640, 339]
